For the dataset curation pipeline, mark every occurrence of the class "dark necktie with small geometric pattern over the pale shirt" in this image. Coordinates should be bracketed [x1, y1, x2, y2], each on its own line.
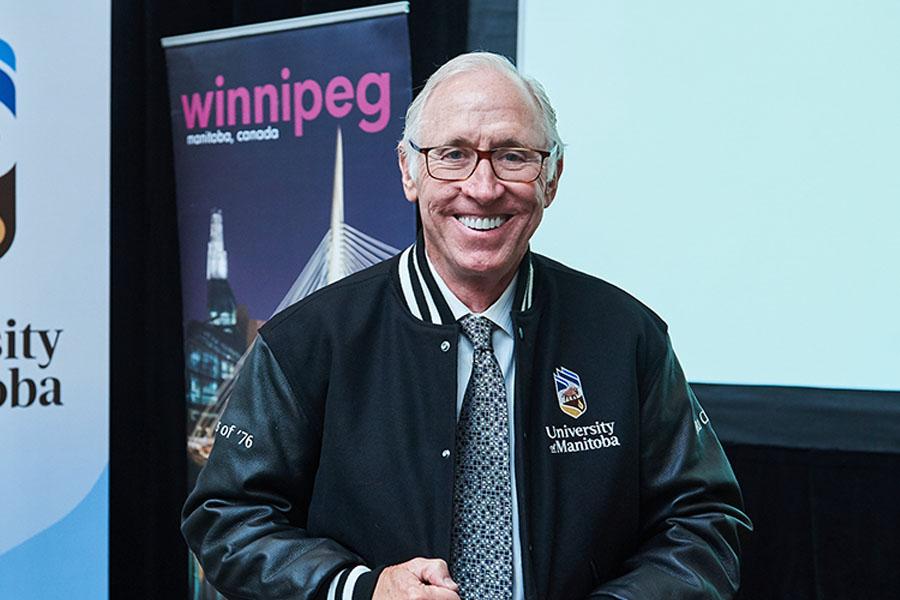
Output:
[450, 315, 513, 600]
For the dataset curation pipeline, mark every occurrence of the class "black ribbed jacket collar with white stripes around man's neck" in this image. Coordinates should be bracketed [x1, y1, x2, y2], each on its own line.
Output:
[398, 236, 534, 325]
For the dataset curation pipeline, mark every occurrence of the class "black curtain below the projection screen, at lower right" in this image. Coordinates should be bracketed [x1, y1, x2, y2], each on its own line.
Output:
[725, 443, 900, 600]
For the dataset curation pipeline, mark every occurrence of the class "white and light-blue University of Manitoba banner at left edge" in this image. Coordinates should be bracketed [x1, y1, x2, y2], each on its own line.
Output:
[0, 0, 111, 600]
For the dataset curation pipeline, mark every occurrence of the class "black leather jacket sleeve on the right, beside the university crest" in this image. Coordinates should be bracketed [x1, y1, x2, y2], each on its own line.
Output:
[590, 340, 752, 600]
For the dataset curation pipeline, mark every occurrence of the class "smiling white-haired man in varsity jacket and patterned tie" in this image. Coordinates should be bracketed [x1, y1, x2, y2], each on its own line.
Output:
[183, 53, 750, 600]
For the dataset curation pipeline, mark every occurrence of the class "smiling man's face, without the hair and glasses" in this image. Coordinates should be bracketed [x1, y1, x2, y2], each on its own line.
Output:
[400, 70, 556, 288]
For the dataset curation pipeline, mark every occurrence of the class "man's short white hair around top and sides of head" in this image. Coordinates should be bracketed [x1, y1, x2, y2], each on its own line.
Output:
[397, 52, 563, 183]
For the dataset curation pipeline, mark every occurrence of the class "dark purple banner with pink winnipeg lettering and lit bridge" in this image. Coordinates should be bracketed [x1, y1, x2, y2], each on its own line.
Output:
[162, 2, 415, 598]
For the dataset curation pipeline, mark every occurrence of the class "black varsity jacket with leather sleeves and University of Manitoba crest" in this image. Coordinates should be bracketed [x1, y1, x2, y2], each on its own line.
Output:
[182, 243, 751, 600]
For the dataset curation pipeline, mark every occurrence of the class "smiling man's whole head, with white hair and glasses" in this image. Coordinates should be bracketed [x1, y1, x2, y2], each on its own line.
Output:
[400, 62, 562, 312]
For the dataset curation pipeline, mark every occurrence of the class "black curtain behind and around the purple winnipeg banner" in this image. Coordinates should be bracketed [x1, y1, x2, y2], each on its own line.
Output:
[110, 0, 468, 599]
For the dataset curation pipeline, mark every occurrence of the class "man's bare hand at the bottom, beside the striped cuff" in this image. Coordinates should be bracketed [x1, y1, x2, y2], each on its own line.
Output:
[372, 558, 459, 600]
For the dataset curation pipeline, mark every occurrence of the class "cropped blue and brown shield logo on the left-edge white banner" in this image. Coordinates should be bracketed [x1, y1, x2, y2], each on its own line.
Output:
[0, 39, 16, 256]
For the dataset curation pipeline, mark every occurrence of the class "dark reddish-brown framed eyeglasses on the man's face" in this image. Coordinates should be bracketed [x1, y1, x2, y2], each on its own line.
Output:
[409, 140, 551, 183]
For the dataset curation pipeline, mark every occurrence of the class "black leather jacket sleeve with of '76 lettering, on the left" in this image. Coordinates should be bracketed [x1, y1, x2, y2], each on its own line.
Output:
[182, 338, 363, 600]
